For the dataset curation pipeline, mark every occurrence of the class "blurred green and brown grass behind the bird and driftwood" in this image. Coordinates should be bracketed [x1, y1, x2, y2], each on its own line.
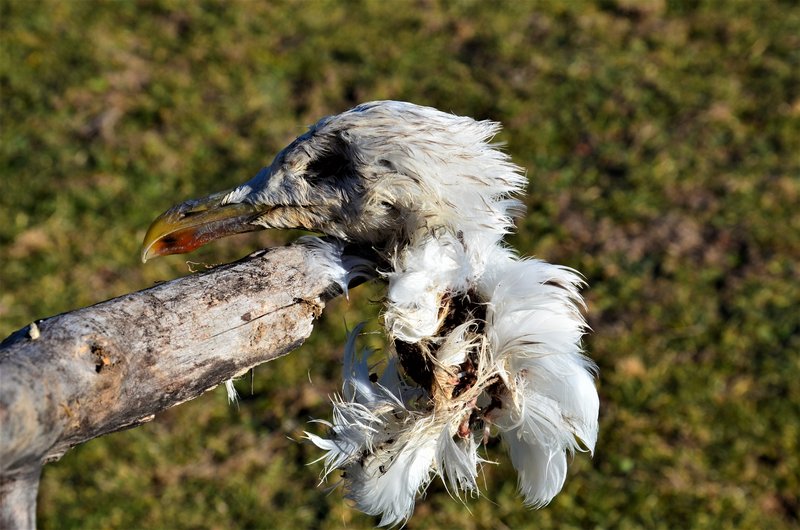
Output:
[0, 0, 800, 529]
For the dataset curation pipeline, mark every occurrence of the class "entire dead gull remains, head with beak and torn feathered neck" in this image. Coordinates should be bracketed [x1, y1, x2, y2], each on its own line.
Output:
[143, 101, 599, 525]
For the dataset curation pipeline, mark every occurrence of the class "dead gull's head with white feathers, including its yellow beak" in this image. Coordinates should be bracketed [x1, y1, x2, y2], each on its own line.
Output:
[142, 101, 525, 261]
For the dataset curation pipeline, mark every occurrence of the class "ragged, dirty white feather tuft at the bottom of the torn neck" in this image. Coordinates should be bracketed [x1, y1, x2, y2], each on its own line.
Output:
[305, 324, 496, 526]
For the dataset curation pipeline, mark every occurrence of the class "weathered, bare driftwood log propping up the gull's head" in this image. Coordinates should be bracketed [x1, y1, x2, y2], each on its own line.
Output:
[0, 241, 350, 528]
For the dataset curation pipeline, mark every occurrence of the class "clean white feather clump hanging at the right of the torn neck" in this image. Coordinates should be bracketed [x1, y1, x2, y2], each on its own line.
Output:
[481, 250, 599, 506]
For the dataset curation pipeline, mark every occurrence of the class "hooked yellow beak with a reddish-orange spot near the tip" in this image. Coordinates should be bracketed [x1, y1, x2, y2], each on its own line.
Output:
[142, 191, 268, 263]
